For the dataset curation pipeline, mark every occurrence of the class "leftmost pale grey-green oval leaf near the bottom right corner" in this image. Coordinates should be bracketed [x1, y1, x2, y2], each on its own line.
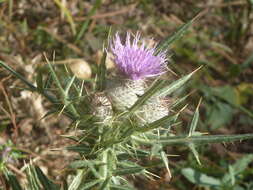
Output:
[181, 168, 221, 186]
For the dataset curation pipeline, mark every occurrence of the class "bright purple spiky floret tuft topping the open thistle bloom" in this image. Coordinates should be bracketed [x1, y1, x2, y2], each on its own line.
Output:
[111, 32, 167, 80]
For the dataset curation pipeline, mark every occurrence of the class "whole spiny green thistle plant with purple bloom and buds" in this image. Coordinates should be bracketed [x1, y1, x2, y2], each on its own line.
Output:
[0, 15, 253, 190]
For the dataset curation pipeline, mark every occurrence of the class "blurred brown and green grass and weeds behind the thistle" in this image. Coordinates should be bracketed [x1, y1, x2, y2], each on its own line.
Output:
[0, 0, 253, 190]
